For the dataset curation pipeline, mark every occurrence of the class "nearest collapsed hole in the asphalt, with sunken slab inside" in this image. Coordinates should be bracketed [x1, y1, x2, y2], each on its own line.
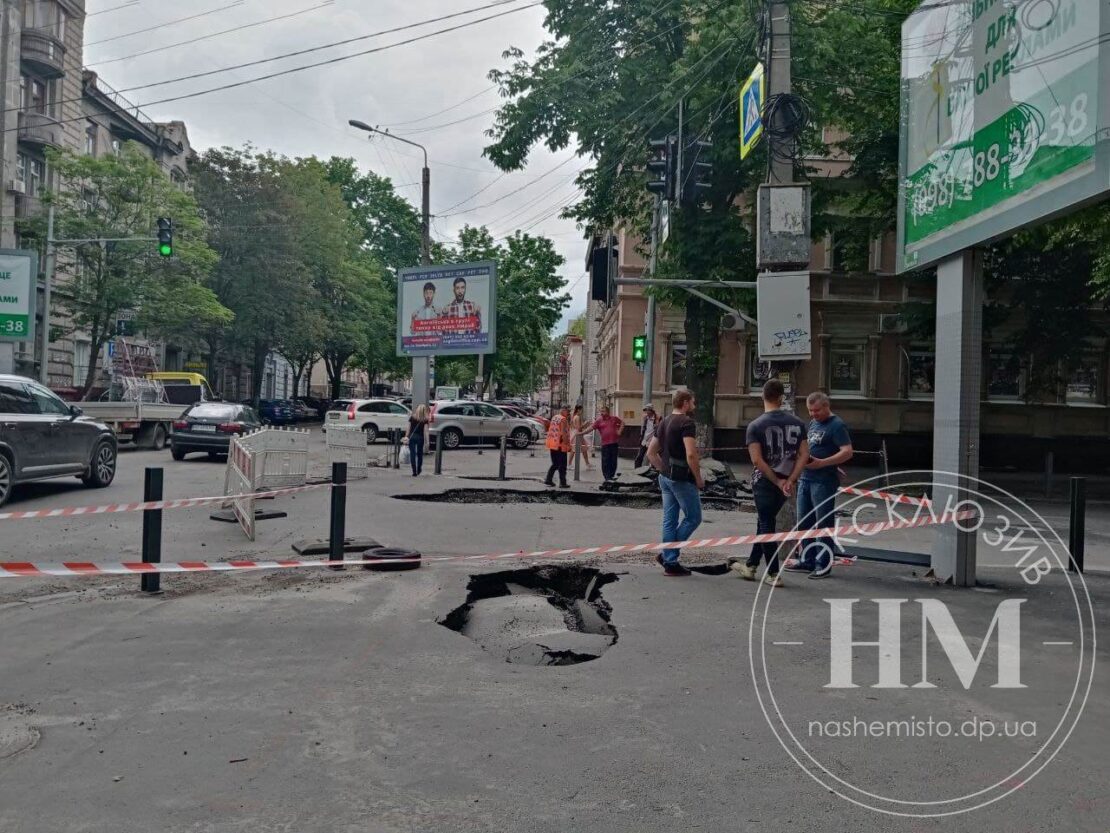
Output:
[438, 565, 617, 665]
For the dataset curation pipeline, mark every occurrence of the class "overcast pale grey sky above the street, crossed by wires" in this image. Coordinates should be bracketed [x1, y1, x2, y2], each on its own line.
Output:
[84, 0, 587, 326]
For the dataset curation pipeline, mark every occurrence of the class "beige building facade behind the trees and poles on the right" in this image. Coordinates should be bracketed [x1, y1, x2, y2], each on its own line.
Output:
[587, 228, 1110, 471]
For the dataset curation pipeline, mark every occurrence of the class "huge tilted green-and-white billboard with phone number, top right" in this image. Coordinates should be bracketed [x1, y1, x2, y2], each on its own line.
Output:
[898, 0, 1110, 272]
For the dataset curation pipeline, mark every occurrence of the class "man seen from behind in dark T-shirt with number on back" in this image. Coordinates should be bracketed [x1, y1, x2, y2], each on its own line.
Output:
[730, 379, 809, 588]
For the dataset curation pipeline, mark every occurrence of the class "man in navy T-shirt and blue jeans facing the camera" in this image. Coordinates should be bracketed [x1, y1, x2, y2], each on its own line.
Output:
[786, 391, 852, 579]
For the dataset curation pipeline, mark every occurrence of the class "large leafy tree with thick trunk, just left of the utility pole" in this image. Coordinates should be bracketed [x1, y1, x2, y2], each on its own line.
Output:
[485, 0, 763, 437]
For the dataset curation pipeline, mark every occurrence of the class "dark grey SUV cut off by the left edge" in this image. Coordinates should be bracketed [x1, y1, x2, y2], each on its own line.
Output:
[0, 374, 119, 505]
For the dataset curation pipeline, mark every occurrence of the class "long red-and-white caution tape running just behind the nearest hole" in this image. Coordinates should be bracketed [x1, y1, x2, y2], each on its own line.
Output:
[0, 508, 976, 579]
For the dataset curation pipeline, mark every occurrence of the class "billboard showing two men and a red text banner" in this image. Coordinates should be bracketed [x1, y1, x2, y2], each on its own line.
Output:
[397, 261, 497, 358]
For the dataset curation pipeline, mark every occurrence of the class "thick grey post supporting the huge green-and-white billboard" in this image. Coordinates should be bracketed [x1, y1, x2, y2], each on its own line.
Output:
[932, 249, 983, 586]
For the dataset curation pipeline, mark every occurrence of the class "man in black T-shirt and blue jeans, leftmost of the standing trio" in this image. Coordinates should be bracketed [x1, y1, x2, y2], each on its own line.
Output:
[647, 391, 705, 576]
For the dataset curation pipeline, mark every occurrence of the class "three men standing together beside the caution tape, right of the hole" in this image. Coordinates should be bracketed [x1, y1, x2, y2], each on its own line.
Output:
[647, 379, 852, 588]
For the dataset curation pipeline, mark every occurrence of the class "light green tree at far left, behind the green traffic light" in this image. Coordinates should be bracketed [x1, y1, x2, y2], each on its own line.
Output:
[21, 142, 223, 398]
